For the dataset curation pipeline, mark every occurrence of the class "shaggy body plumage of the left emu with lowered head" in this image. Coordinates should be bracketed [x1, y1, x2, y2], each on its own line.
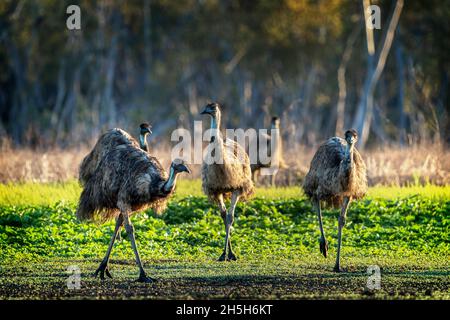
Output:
[76, 143, 173, 222]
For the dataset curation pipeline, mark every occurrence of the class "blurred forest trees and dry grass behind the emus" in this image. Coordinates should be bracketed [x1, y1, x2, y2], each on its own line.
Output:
[0, 0, 450, 184]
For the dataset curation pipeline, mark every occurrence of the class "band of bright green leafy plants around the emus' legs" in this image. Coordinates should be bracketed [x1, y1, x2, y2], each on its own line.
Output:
[0, 191, 450, 262]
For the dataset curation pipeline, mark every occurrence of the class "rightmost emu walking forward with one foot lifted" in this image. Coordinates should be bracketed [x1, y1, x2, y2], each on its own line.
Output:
[303, 129, 367, 272]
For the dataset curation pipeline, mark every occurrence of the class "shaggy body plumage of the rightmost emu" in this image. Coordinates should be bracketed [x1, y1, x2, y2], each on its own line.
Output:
[303, 137, 367, 207]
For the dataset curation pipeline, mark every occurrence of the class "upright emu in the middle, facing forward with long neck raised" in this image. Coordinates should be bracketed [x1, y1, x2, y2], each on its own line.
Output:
[201, 103, 254, 261]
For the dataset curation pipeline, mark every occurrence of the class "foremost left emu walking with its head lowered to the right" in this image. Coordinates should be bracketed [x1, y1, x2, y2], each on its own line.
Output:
[76, 129, 190, 282]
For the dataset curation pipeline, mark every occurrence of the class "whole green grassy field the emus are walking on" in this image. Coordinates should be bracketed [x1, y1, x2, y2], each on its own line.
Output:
[0, 180, 450, 299]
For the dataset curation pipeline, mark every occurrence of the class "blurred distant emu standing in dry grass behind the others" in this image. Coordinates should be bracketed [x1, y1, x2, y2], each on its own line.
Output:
[247, 116, 286, 186]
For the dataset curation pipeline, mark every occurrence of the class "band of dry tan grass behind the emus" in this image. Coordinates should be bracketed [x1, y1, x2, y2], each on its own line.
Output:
[0, 145, 450, 186]
